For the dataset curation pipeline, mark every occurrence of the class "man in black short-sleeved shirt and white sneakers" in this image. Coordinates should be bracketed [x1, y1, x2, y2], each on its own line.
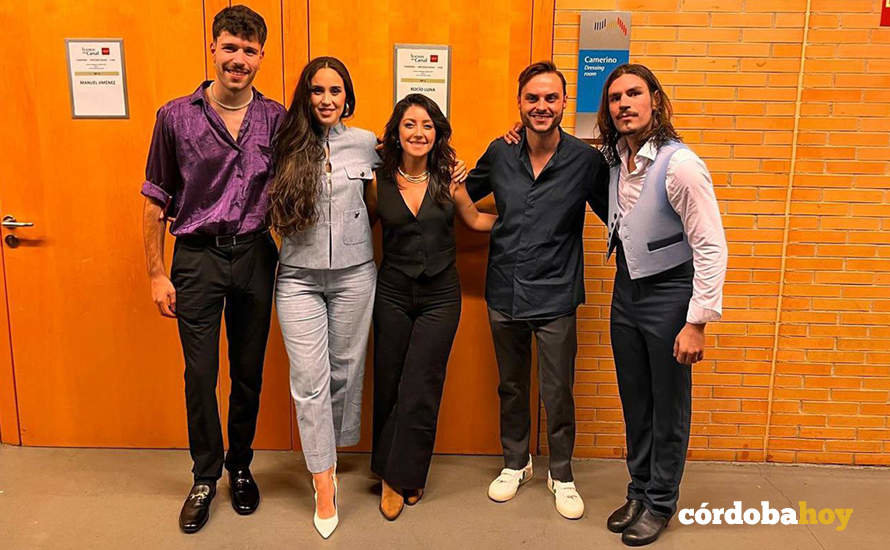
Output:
[466, 62, 609, 519]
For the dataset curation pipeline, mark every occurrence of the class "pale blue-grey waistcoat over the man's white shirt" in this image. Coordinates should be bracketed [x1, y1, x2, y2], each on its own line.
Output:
[606, 141, 692, 279]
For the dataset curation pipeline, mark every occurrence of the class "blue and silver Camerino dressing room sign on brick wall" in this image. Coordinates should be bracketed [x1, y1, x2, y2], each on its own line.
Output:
[575, 11, 630, 138]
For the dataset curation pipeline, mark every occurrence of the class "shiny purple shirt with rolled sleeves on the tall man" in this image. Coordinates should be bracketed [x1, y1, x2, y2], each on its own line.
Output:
[142, 80, 286, 236]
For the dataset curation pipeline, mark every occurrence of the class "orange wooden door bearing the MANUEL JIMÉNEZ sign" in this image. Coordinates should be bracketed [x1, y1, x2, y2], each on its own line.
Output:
[0, 0, 291, 448]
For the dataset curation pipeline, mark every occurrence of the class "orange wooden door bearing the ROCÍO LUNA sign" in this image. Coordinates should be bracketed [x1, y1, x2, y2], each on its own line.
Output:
[306, 0, 534, 454]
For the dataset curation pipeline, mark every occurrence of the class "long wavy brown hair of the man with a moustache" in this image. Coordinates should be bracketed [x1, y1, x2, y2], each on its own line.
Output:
[596, 63, 681, 165]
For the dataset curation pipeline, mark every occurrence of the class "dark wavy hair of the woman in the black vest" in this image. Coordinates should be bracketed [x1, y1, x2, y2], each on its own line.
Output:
[381, 94, 455, 203]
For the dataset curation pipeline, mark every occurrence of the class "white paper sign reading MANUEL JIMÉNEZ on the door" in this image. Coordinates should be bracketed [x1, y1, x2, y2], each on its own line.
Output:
[65, 38, 130, 118]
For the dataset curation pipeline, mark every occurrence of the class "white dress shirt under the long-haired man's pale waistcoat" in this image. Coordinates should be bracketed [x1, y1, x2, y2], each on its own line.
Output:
[618, 138, 728, 324]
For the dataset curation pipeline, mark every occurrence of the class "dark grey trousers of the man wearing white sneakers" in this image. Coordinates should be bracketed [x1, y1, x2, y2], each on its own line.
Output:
[488, 308, 578, 481]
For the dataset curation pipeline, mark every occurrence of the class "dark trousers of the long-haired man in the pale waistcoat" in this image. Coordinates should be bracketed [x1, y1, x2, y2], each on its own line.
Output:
[611, 246, 694, 517]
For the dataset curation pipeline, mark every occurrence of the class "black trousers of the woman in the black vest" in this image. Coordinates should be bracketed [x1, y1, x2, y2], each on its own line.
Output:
[371, 264, 460, 489]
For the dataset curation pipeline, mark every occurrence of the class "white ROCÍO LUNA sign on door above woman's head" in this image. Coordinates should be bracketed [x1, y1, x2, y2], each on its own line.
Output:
[393, 44, 451, 116]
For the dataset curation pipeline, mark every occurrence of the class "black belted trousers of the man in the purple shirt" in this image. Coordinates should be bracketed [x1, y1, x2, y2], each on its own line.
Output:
[171, 233, 278, 481]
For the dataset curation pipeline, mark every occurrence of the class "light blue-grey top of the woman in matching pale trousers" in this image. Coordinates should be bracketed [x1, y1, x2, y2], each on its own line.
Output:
[279, 123, 380, 269]
